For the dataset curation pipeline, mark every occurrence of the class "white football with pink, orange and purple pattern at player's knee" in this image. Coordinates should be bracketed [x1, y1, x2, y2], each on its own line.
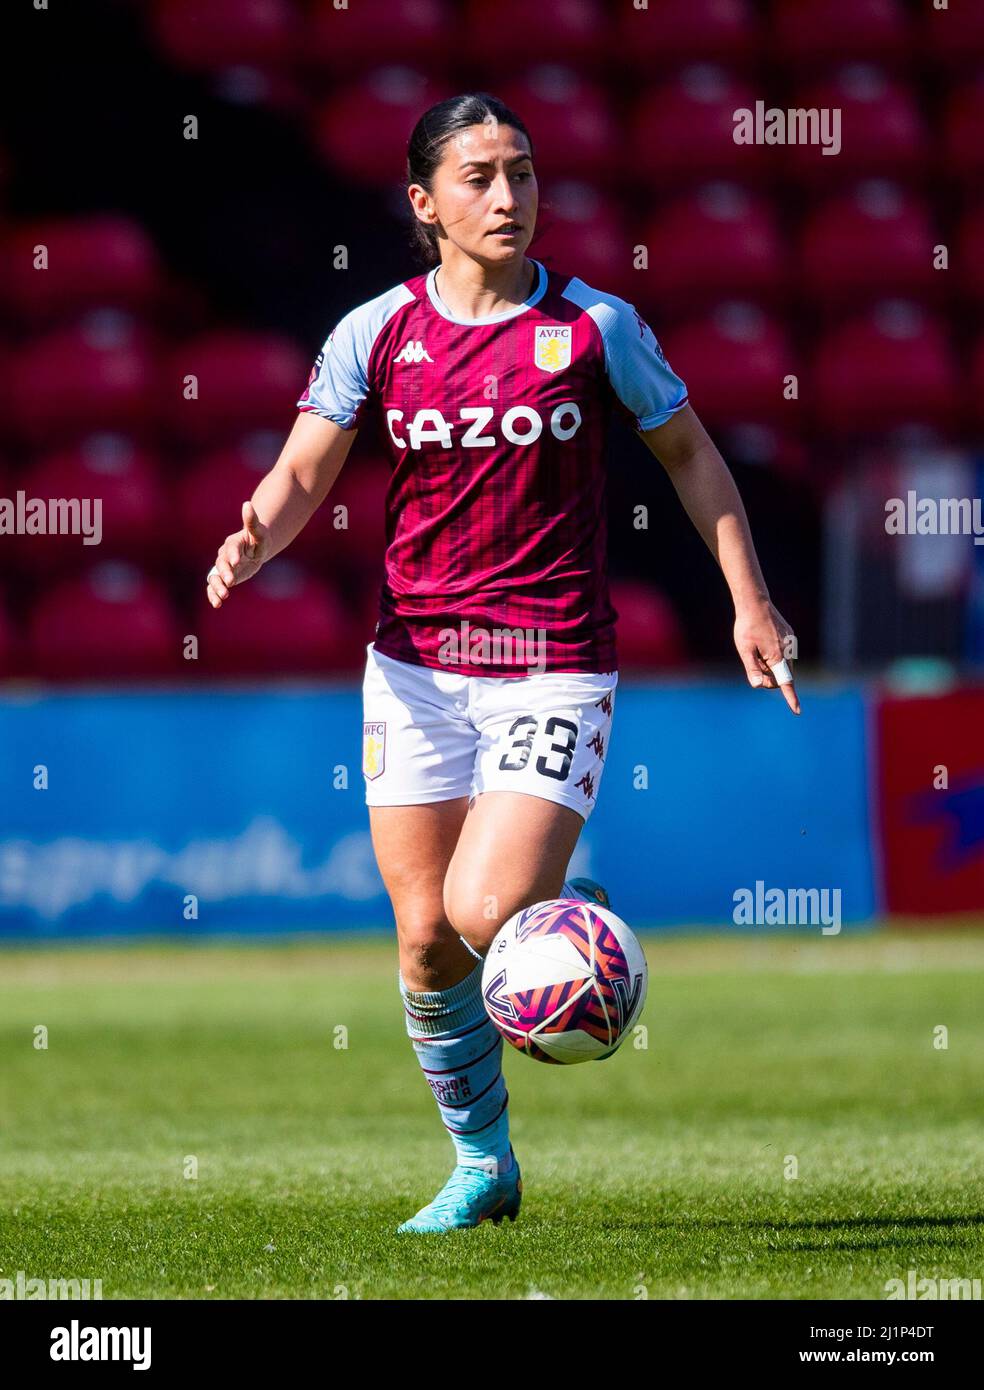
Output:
[482, 898, 648, 1063]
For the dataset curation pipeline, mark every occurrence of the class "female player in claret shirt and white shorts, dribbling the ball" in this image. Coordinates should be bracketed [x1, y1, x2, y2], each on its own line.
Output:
[207, 93, 799, 1233]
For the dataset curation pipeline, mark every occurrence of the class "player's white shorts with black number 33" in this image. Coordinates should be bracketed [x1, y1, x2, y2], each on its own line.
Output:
[363, 642, 618, 820]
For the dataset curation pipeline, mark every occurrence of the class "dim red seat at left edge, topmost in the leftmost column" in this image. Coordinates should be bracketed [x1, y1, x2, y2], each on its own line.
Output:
[0, 215, 163, 324]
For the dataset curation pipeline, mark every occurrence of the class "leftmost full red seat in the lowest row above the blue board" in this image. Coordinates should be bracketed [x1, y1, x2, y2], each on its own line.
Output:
[29, 563, 186, 681]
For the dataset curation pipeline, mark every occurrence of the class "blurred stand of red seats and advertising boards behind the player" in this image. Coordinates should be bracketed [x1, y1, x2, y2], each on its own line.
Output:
[0, 0, 984, 937]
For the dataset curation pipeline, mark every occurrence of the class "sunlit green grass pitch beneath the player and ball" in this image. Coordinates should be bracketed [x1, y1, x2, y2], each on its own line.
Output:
[0, 933, 984, 1298]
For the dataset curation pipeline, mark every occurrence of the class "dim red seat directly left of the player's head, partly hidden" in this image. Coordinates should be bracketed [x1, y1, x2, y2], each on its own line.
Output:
[314, 67, 453, 186]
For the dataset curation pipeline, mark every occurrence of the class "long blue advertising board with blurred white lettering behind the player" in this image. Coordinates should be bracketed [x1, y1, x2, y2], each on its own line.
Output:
[0, 680, 876, 941]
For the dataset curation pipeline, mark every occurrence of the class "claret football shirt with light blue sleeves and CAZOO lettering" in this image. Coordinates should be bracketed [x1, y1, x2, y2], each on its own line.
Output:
[297, 261, 687, 676]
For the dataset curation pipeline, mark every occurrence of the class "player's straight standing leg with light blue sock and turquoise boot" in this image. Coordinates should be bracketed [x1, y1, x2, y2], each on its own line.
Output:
[370, 796, 523, 1234]
